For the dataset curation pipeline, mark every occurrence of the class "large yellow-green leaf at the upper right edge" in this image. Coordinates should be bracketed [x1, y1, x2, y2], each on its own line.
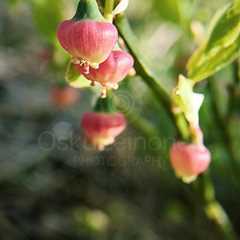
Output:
[187, 2, 240, 82]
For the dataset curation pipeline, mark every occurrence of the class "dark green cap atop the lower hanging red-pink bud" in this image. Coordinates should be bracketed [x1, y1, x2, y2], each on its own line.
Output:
[94, 93, 117, 113]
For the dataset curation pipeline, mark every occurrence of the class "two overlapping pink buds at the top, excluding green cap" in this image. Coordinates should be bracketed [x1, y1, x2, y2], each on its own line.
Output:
[57, 1, 134, 97]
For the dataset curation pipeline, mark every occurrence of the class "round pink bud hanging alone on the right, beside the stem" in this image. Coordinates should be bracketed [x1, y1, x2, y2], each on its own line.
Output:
[170, 142, 211, 183]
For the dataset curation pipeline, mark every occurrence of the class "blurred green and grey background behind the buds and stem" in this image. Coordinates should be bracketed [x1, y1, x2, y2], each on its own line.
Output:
[0, 0, 240, 240]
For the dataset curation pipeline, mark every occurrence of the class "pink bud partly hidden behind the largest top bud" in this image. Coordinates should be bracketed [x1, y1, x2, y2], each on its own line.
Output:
[76, 51, 134, 89]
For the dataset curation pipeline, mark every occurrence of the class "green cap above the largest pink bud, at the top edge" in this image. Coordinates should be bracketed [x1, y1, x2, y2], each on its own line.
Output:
[73, 0, 104, 21]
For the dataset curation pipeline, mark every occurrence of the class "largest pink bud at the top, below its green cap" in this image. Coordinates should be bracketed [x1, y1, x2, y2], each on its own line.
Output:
[57, 20, 118, 71]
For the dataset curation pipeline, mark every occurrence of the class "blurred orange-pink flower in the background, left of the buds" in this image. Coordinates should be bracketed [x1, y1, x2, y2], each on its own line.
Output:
[50, 86, 79, 108]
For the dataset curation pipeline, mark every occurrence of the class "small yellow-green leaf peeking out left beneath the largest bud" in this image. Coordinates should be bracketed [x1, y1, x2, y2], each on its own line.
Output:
[65, 61, 90, 88]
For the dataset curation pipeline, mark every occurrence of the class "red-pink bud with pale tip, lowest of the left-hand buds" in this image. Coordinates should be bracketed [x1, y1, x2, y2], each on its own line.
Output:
[81, 112, 127, 151]
